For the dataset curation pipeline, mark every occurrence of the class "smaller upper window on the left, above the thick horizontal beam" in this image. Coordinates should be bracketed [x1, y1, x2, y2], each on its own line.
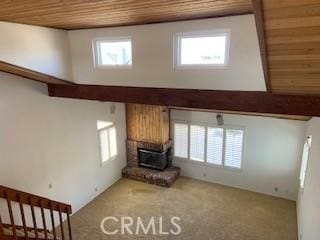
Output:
[94, 38, 132, 68]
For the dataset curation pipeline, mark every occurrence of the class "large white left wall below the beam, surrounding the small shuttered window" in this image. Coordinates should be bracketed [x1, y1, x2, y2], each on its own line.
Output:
[0, 72, 126, 223]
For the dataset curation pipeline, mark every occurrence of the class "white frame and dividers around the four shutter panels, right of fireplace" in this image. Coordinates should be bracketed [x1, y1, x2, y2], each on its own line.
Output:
[171, 120, 246, 172]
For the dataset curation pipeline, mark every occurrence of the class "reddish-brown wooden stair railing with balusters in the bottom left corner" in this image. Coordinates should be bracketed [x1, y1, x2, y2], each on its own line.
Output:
[0, 186, 72, 240]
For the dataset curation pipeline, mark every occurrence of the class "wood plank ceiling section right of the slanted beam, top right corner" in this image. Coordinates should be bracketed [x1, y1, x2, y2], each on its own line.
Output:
[263, 0, 320, 94]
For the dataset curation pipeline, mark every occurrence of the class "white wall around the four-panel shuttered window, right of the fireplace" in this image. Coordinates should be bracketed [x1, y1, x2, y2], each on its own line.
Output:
[171, 110, 306, 200]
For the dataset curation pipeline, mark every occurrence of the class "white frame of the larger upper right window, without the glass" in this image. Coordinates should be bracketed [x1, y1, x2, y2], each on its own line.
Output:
[173, 29, 231, 69]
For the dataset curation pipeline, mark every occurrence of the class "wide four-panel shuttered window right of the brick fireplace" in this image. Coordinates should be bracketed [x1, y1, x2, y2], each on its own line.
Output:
[174, 123, 244, 169]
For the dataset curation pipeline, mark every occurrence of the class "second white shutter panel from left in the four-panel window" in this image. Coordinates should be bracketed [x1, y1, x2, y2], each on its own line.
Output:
[190, 125, 206, 162]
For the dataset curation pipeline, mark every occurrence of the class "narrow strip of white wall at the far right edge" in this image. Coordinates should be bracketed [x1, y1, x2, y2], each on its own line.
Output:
[297, 118, 320, 240]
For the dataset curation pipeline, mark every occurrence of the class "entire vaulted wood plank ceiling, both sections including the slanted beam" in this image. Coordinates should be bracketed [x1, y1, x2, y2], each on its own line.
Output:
[0, 0, 320, 95]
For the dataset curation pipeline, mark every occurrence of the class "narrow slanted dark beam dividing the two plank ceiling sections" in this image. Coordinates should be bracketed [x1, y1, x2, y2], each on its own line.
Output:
[252, 0, 271, 92]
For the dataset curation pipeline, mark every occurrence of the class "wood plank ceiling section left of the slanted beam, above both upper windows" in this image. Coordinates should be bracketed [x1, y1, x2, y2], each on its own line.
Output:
[0, 0, 252, 30]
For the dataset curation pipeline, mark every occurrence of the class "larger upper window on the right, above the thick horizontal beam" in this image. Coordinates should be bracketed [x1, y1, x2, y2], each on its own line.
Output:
[175, 31, 230, 68]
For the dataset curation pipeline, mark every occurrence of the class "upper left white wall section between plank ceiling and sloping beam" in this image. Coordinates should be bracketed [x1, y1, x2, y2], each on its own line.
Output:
[0, 21, 72, 81]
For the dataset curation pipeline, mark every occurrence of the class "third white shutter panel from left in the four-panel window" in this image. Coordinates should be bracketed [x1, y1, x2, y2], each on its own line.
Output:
[207, 127, 223, 165]
